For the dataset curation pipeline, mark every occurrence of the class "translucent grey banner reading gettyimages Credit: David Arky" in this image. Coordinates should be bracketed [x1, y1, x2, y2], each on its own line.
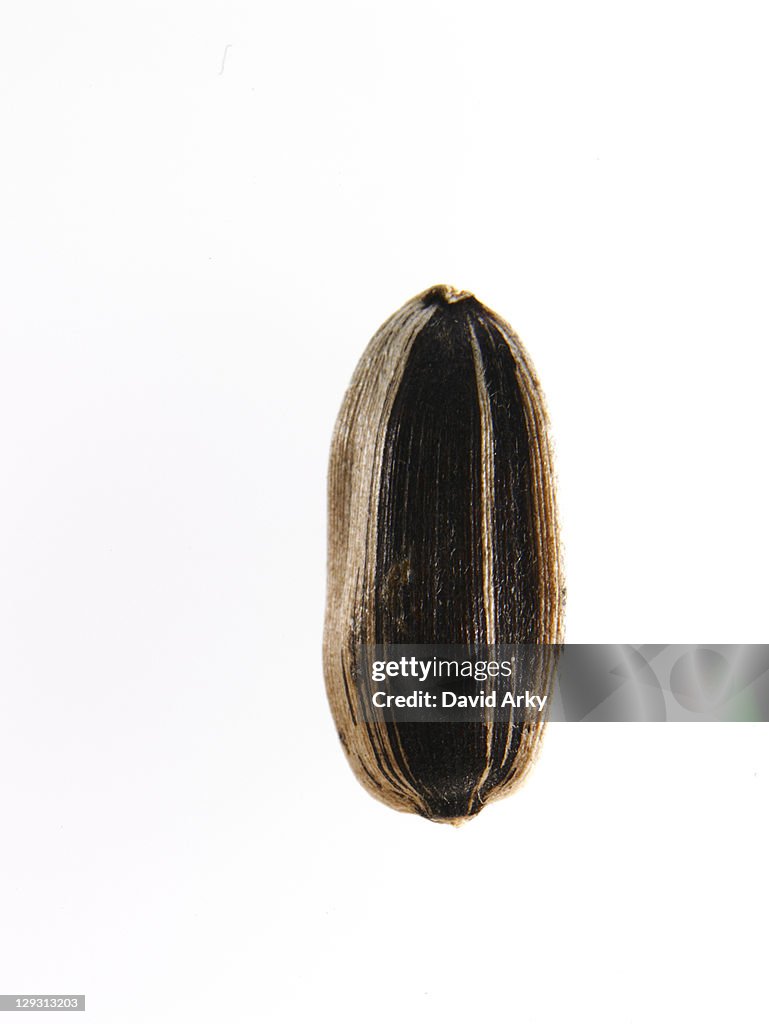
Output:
[354, 644, 769, 722]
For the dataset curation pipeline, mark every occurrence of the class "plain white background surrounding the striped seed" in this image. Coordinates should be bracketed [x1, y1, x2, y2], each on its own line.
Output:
[0, 0, 769, 1024]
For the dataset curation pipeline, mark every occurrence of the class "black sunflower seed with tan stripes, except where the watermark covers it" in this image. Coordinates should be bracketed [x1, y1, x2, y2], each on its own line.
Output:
[324, 286, 564, 823]
